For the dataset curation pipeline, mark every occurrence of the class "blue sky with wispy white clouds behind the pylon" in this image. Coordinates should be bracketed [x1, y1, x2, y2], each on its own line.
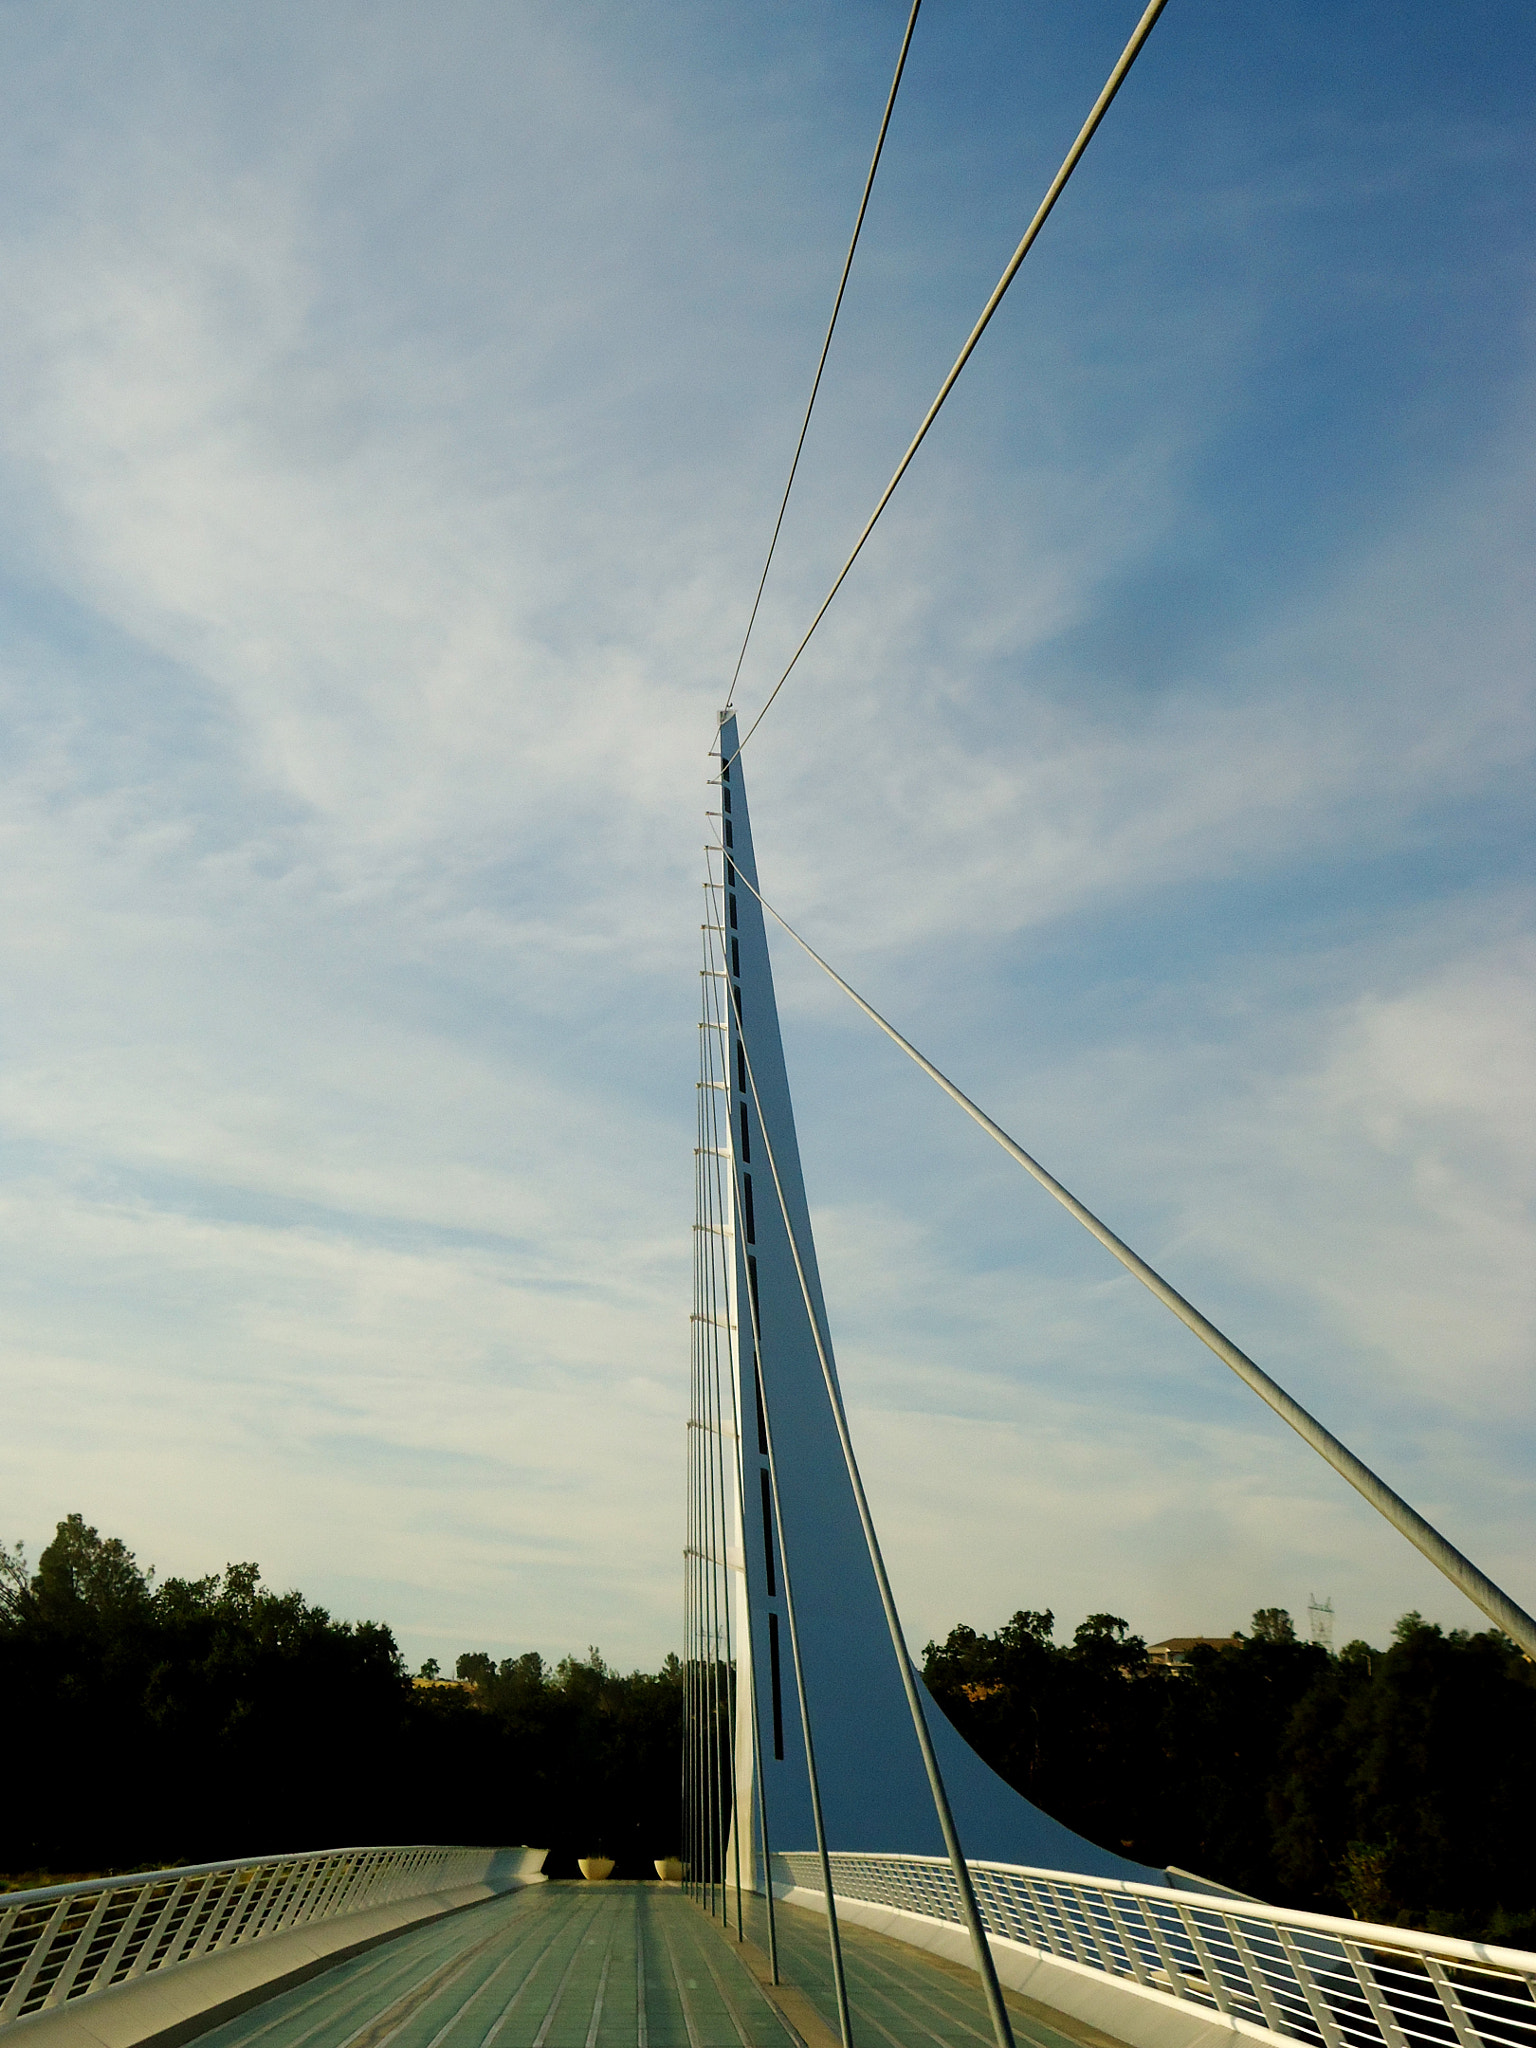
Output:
[0, 0, 1536, 1663]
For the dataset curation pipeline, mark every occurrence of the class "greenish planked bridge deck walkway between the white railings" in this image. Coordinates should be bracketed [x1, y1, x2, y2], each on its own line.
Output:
[203, 1884, 1104, 2048]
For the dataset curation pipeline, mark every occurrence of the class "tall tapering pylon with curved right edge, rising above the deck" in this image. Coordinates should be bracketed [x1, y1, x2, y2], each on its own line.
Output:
[690, 717, 1169, 1892]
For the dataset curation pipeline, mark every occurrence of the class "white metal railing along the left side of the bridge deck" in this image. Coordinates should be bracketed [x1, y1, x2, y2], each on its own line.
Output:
[0, 1847, 489, 2028]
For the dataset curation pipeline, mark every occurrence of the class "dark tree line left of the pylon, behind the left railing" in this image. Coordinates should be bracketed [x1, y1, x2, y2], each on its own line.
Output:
[0, 1516, 682, 1876]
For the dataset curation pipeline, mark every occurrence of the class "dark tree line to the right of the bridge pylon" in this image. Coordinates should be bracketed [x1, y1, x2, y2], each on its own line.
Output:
[926, 1608, 1536, 1948]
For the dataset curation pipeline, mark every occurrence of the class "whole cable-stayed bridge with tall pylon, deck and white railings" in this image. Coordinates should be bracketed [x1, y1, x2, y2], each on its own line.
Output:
[0, 715, 1536, 2048]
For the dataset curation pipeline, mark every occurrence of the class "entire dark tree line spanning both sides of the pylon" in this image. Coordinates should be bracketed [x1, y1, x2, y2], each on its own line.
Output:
[0, 1516, 1536, 1946]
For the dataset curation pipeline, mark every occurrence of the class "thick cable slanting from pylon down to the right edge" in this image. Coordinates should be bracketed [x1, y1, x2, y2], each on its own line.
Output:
[735, 847, 1536, 1661]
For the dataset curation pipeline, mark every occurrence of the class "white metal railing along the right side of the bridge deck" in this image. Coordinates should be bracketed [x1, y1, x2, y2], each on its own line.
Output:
[774, 1853, 1536, 2048]
